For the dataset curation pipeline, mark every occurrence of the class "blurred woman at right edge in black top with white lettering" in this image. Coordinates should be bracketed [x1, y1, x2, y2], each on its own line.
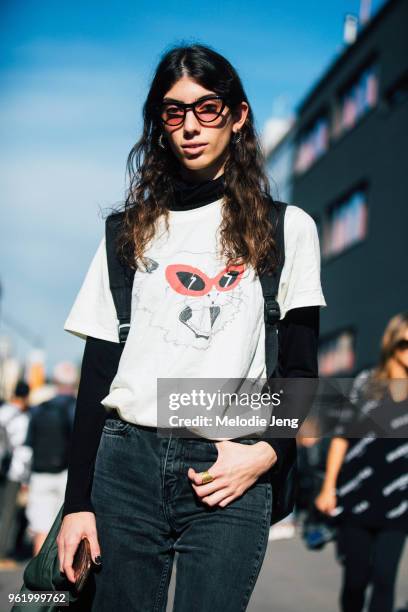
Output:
[315, 313, 408, 612]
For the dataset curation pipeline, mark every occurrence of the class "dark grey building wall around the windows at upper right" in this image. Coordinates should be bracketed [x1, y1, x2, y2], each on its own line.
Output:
[293, 0, 408, 371]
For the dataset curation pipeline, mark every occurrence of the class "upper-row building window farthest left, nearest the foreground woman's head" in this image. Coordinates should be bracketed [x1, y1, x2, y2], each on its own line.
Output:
[294, 116, 329, 174]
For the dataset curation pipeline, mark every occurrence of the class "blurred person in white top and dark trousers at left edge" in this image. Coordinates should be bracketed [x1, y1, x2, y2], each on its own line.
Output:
[0, 381, 31, 565]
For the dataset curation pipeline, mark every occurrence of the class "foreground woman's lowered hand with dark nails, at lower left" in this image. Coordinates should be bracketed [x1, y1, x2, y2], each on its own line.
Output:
[57, 512, 101, 582]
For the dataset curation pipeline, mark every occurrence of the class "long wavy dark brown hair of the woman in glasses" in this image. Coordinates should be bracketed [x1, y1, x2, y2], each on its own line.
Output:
[118, 44, 277, 273]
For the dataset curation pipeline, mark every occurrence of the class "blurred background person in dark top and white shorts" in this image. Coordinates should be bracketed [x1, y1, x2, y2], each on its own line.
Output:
[26, 362, 77, 556]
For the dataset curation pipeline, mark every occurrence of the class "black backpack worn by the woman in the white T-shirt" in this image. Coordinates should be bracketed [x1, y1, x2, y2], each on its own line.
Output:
[105, 198, 297, 525]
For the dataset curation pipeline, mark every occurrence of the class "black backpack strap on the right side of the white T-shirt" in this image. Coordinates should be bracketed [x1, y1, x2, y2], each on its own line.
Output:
[259, 198, 287, 379]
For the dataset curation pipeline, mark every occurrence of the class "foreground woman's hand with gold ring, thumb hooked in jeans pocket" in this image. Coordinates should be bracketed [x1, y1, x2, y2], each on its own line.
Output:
[187, 440, 277, 508]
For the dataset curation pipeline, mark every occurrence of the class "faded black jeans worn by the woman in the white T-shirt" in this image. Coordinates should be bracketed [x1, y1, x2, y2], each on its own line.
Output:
[92, 418, 272, 612]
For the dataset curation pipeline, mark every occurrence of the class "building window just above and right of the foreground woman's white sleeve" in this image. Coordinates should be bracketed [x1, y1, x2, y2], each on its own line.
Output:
[322, 189, 368, 257]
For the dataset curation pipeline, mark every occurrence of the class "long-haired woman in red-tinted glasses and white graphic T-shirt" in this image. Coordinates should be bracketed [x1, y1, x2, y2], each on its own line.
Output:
[58, 45, 325, 612]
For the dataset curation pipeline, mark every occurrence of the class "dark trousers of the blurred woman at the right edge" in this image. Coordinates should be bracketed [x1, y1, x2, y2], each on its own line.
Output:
[338, 524, 406, 612]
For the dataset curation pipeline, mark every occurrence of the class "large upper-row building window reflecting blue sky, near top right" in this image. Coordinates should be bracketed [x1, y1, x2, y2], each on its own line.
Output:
[333, 64, 378, 138]
